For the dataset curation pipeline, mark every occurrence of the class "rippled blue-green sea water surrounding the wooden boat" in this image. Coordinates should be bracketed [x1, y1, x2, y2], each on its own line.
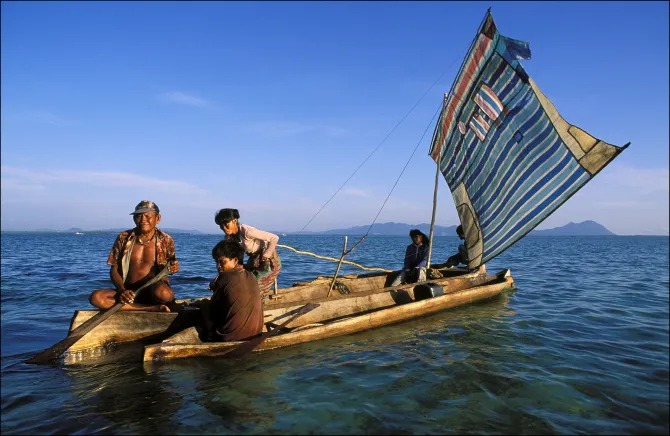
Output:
[2, 233, 670, 434]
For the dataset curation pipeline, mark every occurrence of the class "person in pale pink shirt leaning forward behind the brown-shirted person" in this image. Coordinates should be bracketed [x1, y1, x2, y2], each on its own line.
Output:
[214, 209, 281, 295]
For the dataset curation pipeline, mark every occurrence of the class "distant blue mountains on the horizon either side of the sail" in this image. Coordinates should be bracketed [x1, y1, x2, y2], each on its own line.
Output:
[296, 221, 614, 236]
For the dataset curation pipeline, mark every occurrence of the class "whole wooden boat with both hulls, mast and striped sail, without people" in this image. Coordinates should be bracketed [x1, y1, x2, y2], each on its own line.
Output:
[32, 10, 629, 363]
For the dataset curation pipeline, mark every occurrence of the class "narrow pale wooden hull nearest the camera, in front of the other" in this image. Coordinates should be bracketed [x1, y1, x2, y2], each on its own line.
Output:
[144, 270, 514, 362]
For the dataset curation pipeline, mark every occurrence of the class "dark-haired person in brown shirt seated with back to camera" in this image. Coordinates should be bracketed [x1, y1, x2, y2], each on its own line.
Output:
[203, 239, 263, 341]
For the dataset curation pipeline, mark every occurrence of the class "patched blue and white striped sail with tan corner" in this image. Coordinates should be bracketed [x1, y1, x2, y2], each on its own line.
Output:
[430, 12, 628, 268]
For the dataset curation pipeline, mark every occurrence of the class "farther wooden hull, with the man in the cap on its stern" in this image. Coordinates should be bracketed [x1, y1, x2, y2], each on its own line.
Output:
[64, 267, 491, 363]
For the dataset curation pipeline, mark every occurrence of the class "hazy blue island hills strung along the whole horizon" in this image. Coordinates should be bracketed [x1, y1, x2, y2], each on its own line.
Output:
[0, 221, 616, 236]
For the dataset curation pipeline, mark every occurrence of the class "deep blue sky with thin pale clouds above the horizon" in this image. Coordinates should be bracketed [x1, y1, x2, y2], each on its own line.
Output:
[1, 2, 669, 235]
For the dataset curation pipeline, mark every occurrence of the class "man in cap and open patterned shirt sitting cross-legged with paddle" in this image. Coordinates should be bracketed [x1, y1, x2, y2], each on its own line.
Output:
[89, 200, 184, 312]
